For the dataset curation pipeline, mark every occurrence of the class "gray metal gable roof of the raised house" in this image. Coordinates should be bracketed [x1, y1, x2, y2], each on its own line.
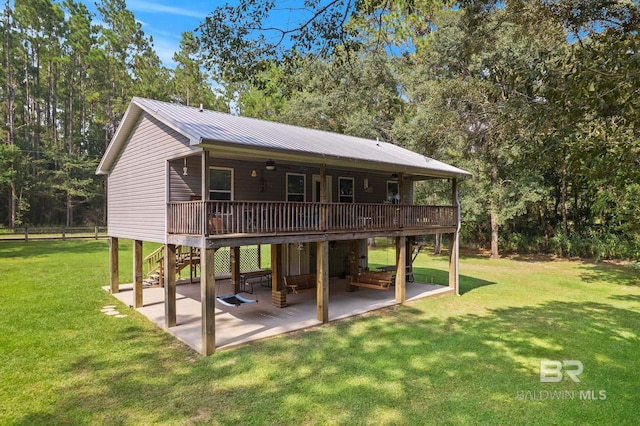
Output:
[97, 97, 471, 179]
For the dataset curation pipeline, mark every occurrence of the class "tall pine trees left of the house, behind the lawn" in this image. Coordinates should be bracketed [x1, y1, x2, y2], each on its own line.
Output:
[0, 0, 228, 228]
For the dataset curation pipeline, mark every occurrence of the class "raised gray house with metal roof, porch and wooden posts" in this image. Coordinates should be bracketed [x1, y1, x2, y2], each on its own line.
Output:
[96, 98, 470, 355]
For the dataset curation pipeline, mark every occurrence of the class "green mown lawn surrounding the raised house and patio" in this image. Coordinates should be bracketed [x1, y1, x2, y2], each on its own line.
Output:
[0, 240, 640, 425]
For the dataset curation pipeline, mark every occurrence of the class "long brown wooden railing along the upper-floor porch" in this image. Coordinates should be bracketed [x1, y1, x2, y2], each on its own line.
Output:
[167, 201, 457, 236]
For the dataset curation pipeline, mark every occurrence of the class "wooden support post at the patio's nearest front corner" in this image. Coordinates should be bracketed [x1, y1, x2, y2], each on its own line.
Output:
[200, 248, 216, 356]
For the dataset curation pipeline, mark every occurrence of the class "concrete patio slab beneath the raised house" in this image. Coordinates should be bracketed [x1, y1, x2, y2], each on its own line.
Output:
[105, 279, 453, 352]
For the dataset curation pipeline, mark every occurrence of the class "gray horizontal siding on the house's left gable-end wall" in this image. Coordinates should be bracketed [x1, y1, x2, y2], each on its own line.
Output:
[107, 114, 193, 242]
